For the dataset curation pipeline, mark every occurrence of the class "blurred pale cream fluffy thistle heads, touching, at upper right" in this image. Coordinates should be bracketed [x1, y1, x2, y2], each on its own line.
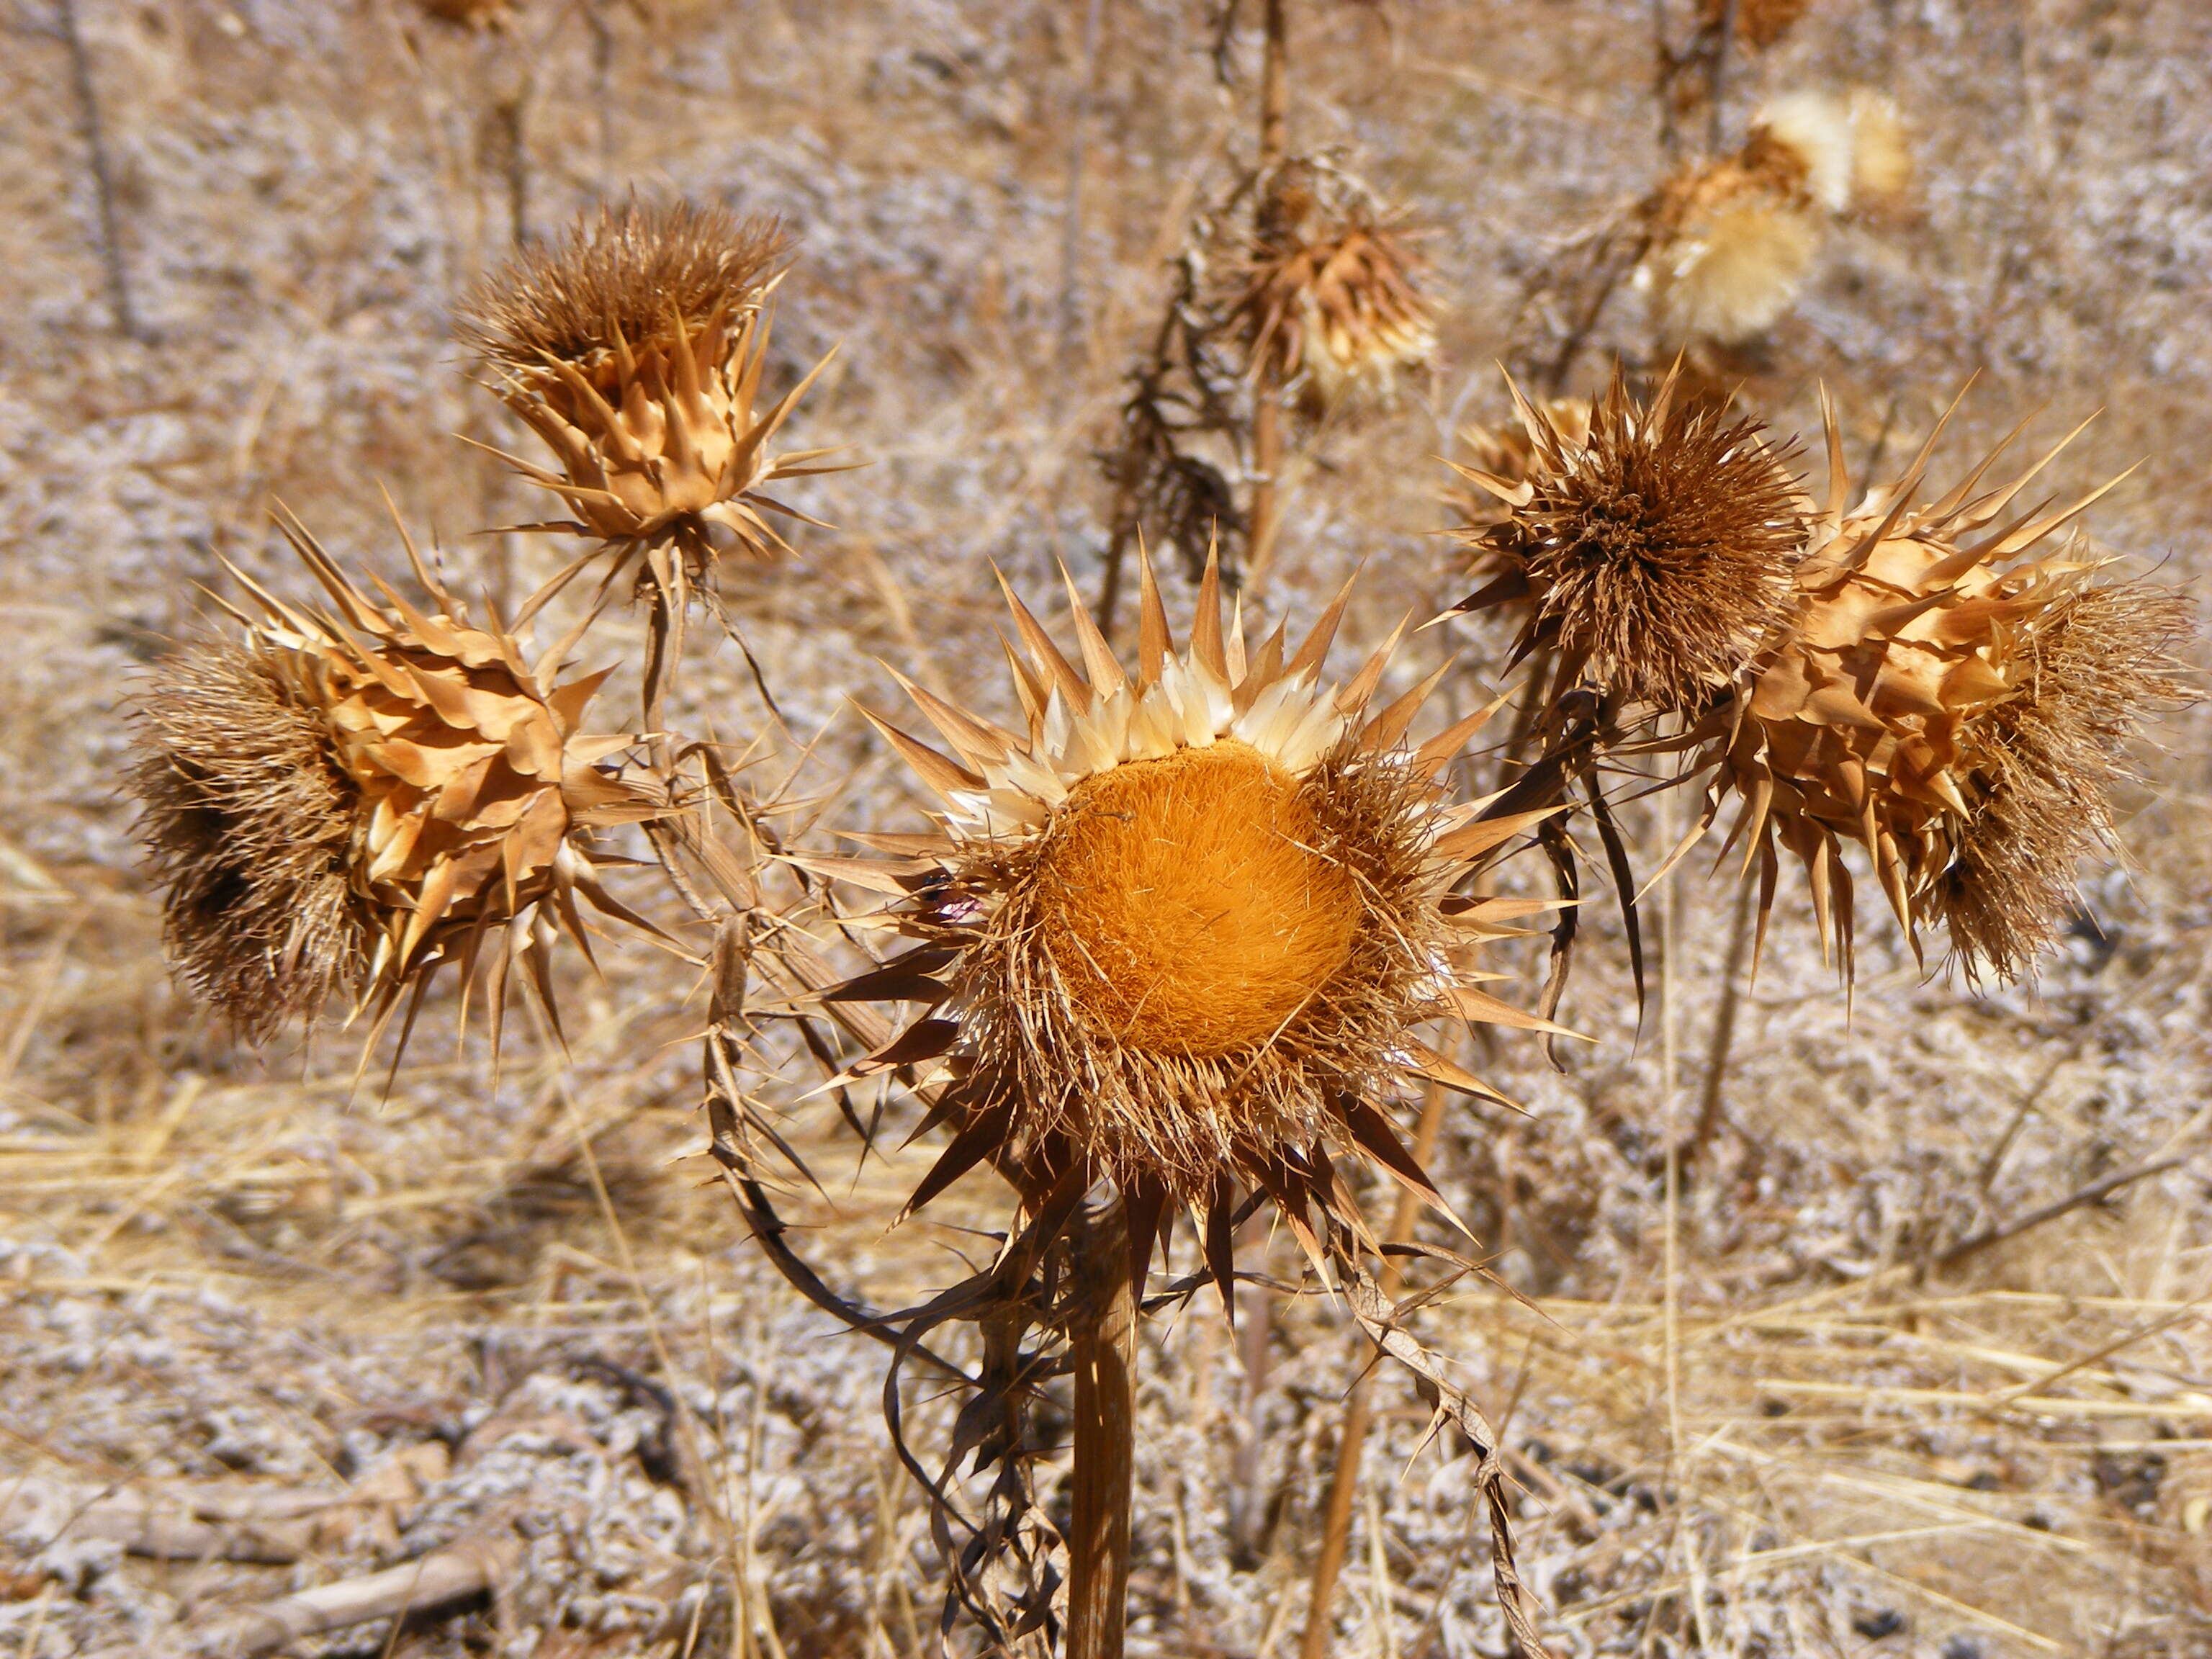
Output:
[1637, 89, 1911, 345]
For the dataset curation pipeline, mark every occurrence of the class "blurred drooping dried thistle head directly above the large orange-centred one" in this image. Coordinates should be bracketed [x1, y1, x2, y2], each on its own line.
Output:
[1228, 159, 1436, 418]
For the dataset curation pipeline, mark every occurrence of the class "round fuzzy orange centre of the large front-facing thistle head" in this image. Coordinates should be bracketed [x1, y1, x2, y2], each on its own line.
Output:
[1038, 741, 1362, 1059]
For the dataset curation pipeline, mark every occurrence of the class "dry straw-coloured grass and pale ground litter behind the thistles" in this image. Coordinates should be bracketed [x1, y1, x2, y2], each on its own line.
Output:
[0, 0, 2212, 1659]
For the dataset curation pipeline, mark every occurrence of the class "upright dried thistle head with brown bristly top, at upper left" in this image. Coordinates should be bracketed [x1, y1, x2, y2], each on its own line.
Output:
[460, 202, 836, 593]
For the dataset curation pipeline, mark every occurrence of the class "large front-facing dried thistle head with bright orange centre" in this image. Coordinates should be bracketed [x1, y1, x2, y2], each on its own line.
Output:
[838, 553, 1548, 1292]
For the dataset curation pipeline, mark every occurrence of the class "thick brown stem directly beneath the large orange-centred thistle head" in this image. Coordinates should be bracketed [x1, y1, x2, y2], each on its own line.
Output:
[1066, 1199, 1137, 1659]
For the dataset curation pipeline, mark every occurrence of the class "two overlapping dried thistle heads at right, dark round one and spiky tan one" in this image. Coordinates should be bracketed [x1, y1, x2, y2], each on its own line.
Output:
[1453, 374, 2188, 978]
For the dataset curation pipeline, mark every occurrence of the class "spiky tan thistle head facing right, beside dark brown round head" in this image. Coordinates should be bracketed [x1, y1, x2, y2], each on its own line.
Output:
[1712, 393, 2190, 978]
